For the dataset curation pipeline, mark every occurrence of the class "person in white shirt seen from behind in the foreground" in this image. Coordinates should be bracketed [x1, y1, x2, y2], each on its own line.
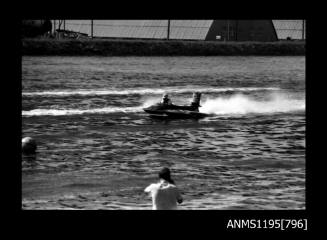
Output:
[144, 167, 183, 210]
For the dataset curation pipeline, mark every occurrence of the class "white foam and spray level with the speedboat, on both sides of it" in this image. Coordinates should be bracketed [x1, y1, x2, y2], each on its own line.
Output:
[22, 93, 305, 117]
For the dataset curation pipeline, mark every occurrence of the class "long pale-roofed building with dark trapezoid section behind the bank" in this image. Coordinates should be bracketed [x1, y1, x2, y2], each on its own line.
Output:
[55, 20, 305, 41]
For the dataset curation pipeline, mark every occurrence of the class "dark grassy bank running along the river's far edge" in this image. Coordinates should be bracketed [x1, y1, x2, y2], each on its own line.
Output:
[22, 39, 305, 56]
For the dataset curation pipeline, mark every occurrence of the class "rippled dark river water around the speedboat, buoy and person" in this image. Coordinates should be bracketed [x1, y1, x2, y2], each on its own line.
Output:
[22, 56, 305, 210]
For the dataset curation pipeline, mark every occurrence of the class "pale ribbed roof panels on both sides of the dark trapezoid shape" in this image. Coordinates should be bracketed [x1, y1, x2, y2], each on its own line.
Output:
[52, 20, 306, 40]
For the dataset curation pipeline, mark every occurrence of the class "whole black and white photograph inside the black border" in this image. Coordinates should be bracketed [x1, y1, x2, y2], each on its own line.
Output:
[21, 19, 306, 213]
